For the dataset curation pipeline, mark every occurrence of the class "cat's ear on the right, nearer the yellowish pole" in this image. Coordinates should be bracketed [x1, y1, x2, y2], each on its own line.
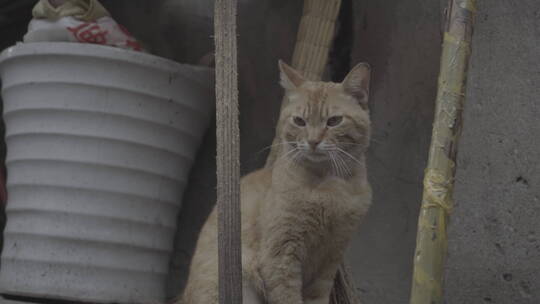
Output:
[342, 62, 371, 109]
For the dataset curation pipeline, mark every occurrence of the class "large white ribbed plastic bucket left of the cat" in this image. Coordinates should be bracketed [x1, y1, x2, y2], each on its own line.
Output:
[0, 43, 214, 303]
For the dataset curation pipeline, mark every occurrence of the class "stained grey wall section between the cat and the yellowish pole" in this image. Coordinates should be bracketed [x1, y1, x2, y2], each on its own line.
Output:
[348, 0, 441, 304]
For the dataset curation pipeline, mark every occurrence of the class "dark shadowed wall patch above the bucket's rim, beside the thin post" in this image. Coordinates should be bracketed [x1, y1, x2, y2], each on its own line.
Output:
[101, 0, 213, 64]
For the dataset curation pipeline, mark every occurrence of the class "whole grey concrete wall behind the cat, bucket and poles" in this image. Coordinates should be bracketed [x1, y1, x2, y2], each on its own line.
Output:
[3, 0, 540, 304]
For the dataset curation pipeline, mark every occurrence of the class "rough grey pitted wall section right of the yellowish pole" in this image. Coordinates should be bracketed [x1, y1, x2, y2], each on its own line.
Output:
[446, 0, 540, 304]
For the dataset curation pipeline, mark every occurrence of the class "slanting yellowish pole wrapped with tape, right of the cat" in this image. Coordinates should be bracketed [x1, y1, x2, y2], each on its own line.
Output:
[411, 0, 476, 304]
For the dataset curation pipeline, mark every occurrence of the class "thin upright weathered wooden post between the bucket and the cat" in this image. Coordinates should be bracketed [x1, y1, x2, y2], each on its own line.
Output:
[214, 0, 242, 304]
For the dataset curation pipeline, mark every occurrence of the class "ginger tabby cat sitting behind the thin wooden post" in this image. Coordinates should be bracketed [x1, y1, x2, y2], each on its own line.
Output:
[177, 61, 371, 304]
